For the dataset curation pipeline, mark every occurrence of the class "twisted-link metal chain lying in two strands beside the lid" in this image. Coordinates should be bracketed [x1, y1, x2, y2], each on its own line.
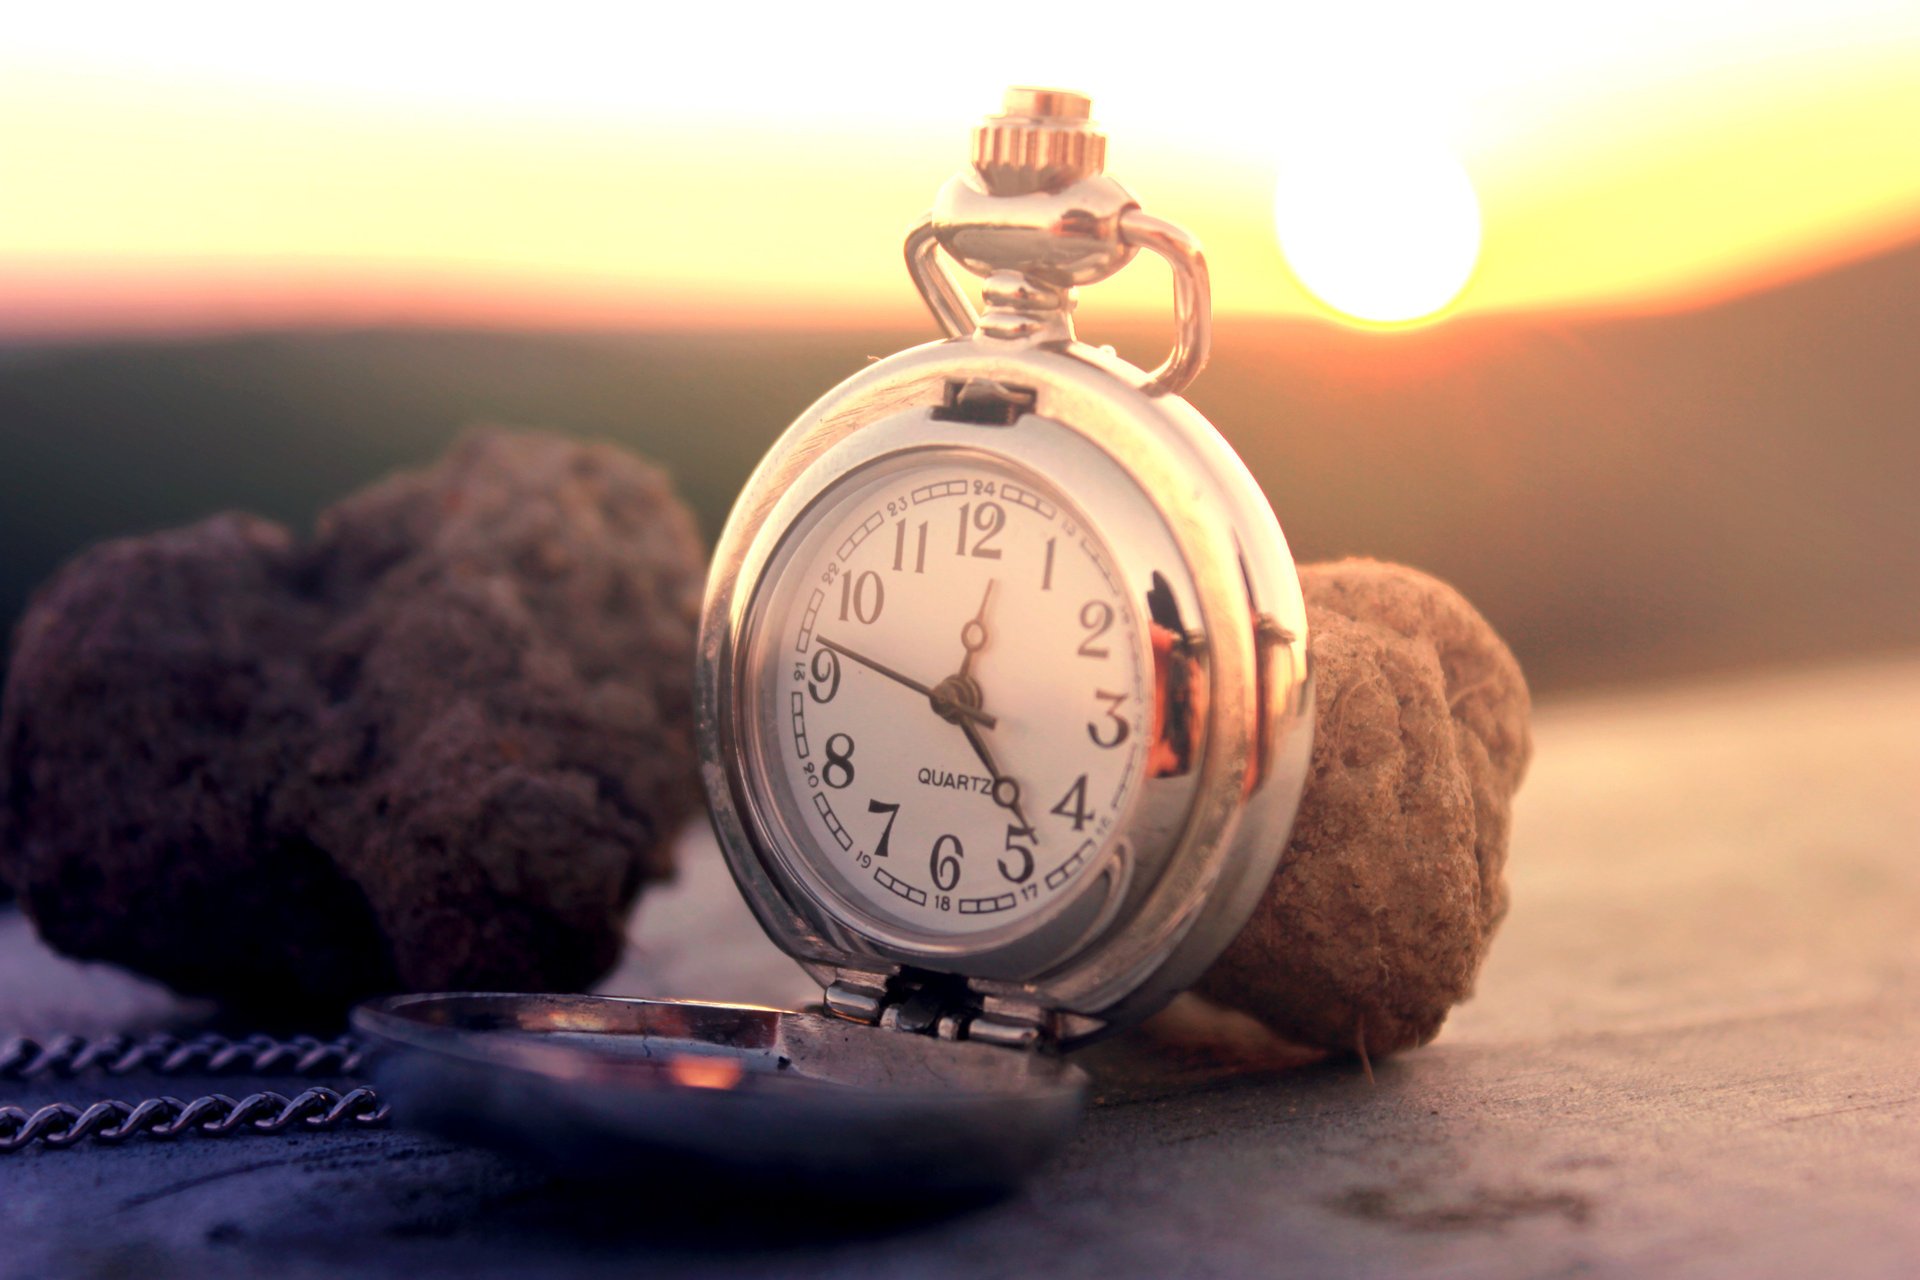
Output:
[0, 1034, 388, 1155]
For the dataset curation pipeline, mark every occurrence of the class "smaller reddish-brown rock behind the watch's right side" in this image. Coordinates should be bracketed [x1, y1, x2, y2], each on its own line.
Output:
[1198, 560, 1532, 1055]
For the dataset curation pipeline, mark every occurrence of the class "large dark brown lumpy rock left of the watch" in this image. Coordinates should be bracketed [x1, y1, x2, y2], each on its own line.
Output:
[0, 430, 703, 1007]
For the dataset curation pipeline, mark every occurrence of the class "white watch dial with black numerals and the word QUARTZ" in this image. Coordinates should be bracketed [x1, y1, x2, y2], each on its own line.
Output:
[743, 449, 1154, 940]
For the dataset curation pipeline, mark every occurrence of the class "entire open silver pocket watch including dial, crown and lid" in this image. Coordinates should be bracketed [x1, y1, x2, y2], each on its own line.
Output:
[357, 88, 1313, 1190]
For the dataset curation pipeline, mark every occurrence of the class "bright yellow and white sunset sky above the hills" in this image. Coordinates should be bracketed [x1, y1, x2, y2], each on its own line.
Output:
[0, 0, 1920, 334]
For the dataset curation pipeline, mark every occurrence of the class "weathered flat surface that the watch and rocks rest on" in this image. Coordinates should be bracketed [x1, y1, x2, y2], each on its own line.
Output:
[0, 660, 1920, 1280]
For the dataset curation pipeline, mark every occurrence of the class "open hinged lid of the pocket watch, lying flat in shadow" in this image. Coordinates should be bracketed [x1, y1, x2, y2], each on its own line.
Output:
[353, 992, 1087, 1197]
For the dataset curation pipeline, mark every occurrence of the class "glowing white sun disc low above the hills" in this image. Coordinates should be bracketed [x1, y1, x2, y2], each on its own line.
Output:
[1273, 130, 1480, 324]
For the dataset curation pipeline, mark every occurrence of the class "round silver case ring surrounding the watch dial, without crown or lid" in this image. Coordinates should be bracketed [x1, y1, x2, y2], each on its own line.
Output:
[695, 332, 1313, 1048]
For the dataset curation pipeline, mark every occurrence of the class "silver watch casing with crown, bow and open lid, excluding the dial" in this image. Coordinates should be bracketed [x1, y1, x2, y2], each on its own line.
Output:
[353, 88, 1313, 1203]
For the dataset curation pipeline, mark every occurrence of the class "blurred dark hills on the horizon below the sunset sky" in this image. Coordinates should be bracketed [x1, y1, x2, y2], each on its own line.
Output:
[0, 235, 1920, 689]
